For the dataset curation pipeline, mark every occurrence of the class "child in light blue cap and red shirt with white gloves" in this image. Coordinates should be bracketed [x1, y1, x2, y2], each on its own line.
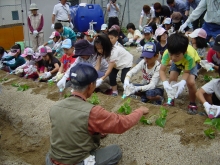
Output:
[52, 39, 76, 81]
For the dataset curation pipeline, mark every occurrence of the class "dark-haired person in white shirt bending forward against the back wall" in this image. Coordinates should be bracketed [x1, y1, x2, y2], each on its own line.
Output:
[139, 5, 156, 31]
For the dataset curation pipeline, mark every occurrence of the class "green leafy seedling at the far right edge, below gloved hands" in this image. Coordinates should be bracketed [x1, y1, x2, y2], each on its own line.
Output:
[204, 118, 220, 139]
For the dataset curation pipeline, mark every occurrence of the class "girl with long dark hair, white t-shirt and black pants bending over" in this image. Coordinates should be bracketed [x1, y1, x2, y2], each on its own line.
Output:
[94, 35, 133, 96]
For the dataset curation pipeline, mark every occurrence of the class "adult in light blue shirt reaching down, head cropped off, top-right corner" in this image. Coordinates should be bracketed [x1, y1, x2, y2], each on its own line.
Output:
[179, 0, 220, 41]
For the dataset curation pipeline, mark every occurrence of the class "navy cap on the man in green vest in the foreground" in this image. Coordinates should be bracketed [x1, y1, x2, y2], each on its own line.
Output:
[70, 63, 98, 86]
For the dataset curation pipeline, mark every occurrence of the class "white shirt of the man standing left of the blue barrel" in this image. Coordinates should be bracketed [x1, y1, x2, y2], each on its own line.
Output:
[53, 3, 70, 21]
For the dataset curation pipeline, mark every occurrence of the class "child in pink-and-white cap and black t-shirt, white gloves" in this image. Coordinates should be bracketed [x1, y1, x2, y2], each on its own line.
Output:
[39, 46, 61, 81]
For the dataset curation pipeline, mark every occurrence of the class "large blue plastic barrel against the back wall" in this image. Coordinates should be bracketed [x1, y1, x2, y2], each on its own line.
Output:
[73, 4, 104, 32]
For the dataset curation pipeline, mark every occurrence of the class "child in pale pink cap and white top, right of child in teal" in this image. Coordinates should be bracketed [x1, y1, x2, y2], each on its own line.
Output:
[15, 48, 38, 80]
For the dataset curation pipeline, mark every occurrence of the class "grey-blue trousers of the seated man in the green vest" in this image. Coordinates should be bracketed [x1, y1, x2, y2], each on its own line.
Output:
[46, 145, 122, 165]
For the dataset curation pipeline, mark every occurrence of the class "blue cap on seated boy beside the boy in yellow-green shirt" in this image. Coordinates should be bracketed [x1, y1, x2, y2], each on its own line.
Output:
[141, 42, 158, 58]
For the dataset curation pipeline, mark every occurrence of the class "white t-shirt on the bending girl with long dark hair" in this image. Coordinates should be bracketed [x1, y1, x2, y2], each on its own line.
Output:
[109, 46, 133, 70]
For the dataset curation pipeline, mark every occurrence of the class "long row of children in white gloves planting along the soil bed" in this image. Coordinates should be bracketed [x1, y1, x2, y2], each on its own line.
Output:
[0, 20, 220, 118]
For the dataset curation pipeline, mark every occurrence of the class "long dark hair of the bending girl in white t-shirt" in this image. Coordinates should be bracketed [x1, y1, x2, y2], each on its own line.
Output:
[94, 35, 113, 58]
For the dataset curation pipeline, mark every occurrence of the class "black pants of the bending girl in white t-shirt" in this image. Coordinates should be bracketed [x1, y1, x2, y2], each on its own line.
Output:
[109, 68, 130, 86]
